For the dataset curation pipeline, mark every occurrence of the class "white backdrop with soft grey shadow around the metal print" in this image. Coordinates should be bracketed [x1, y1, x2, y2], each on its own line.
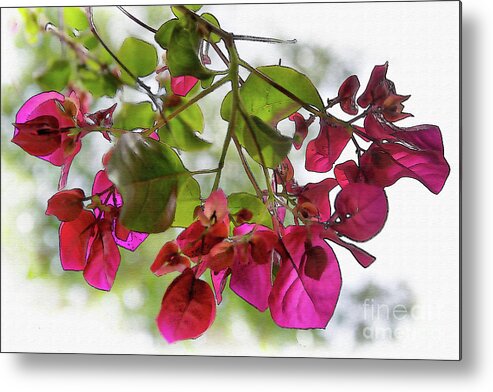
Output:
[0, 0, 493, 390]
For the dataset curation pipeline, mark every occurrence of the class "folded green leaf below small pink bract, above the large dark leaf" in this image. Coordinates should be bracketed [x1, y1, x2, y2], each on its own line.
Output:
[158, 98, 211, 151]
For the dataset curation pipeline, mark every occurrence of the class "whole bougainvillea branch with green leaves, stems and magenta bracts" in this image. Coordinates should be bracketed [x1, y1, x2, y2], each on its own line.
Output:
[12, 6, 450, 343]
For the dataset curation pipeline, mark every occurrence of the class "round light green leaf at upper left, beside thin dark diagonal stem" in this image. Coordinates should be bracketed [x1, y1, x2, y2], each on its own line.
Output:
[117, 37, 158, 83]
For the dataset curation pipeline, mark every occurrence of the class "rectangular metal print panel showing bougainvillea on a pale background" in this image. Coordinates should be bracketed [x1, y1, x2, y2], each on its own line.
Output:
[1, 2, 460, 360]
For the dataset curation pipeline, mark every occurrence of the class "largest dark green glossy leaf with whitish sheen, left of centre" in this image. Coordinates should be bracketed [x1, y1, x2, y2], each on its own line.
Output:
[107, 132, 190, 233]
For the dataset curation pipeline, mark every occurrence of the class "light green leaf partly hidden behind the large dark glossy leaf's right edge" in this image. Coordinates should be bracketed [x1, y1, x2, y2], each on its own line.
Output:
[173, 176, 200, 227]
